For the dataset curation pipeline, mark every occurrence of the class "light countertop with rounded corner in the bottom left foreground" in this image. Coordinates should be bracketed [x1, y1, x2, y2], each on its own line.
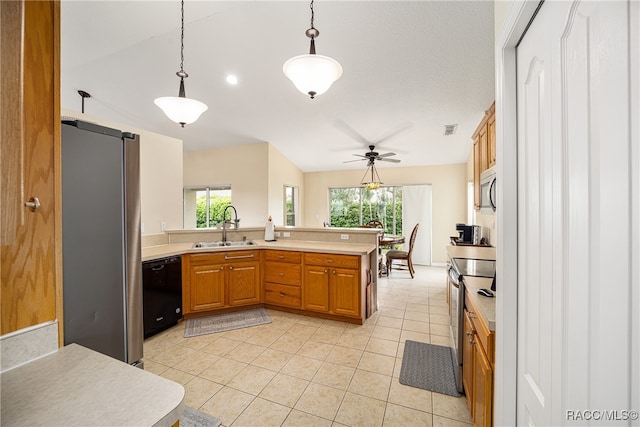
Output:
[0, 344, 184, 427]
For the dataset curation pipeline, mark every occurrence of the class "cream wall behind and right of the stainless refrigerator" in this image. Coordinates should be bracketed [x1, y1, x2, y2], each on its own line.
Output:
[62, 110, 182, 236]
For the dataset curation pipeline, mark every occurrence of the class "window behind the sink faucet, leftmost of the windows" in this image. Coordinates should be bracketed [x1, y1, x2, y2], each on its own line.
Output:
[184, 185, 231, 229]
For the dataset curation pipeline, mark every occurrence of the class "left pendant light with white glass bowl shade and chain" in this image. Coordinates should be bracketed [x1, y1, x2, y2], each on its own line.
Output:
[153, 0, 208, 127]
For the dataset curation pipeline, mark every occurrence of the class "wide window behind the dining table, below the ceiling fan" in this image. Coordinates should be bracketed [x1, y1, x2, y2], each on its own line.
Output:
[329, 187, 402, 234]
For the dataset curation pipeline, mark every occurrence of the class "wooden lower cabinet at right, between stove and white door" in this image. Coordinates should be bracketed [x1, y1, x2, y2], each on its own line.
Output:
[462, 298, 495, 427]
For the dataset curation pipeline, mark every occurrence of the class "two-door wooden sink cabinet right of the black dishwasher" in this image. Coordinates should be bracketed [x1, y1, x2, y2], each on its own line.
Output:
[182, 250, 262, 315]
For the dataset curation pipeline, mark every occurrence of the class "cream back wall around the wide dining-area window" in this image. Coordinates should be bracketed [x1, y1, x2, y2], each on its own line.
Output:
[303, 163, 467, 263]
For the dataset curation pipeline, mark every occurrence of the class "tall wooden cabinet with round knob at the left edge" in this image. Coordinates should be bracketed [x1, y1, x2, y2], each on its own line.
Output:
[0, 1, 64, 343]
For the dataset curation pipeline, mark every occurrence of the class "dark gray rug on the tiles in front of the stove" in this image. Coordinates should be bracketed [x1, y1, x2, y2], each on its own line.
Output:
[399, 340, 460, 397]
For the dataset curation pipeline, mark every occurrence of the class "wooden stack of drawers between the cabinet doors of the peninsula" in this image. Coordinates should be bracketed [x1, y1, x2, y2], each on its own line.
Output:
[264, 249, 302, 308]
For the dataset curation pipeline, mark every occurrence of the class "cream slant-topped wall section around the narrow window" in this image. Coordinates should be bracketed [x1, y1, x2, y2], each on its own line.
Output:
[265, 144, 304, 227]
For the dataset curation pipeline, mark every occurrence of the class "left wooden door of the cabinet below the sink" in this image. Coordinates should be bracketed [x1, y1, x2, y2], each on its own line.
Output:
[190, 264, 225, 311]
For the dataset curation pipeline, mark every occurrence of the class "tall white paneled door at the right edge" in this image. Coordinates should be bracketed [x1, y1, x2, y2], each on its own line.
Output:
[517, 1, 639, 425]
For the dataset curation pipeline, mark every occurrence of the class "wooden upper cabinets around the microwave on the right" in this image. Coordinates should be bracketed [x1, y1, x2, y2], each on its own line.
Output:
[471, 102, 496, 210]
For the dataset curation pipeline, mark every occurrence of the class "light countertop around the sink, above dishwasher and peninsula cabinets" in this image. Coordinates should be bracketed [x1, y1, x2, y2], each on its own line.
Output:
[142, 239, 376, 261]
